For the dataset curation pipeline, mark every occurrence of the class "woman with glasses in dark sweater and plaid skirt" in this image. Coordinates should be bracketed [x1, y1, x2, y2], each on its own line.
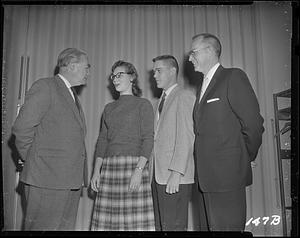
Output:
[91, 61, 155, 231]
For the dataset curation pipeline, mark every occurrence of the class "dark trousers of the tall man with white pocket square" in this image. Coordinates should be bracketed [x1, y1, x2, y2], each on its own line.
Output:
[203, 188, 246, 231]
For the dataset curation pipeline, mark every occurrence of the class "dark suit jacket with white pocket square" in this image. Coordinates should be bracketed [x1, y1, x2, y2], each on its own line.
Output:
[193, 65, 264, 192]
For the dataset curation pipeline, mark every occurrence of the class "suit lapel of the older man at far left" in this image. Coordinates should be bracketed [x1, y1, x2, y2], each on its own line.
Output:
[54, 75, 86, 131]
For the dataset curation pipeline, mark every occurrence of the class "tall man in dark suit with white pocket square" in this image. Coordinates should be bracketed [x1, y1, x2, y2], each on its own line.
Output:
[189, 33, 264, 231]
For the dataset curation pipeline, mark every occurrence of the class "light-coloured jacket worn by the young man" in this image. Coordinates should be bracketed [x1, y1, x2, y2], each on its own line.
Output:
[150, 85, 196, 184]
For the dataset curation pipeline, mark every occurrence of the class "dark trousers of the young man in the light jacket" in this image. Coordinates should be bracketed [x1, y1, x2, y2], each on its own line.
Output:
[151, 178, 192, 231]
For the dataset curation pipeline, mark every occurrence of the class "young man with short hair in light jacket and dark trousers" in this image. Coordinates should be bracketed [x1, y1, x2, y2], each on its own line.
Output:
[150, 55, 195, 231]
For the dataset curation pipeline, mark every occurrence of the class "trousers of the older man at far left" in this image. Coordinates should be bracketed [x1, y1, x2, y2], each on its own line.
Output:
[25, 184, 81, 231]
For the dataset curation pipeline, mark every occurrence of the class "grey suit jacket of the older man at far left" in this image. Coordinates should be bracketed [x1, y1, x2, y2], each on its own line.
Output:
[12, 76, 87, 189]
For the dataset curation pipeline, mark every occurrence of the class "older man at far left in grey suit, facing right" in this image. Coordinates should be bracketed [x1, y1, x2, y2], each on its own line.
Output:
[12, 48, 89, 230]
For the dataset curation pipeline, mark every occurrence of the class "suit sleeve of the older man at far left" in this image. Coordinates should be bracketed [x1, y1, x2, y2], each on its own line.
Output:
[12, 80, 51, 160]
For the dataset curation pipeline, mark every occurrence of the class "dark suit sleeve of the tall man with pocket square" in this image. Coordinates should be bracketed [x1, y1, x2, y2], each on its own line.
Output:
[228, 70, 264, 161]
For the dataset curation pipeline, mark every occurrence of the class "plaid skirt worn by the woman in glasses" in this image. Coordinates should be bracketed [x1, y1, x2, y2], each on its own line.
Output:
[91, 156, 155, 231]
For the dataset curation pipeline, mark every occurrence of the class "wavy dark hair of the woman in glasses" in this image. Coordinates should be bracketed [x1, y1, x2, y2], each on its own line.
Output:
[111, 60, 142, 97]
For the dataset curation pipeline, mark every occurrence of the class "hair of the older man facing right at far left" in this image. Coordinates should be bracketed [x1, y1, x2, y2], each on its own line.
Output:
[57, 48, 87, 68]
